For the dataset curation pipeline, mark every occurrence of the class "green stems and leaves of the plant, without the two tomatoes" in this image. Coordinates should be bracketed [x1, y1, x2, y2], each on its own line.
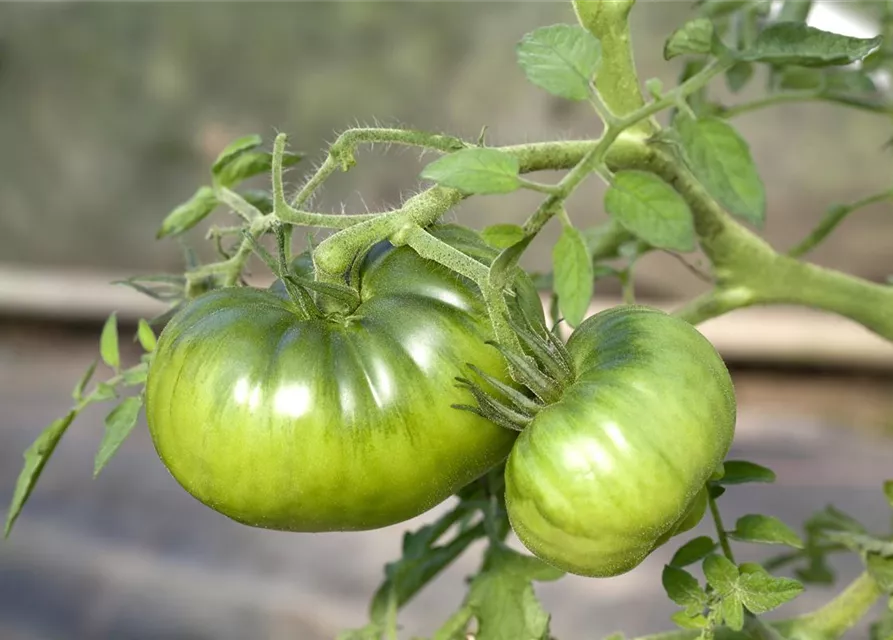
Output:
[6, 0, 893, 640]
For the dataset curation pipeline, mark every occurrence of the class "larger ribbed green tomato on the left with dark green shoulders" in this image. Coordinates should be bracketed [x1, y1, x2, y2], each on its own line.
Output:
[146, 229, 542, 531]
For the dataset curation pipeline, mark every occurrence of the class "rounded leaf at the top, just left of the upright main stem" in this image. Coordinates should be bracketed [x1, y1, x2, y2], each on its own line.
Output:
[516, 24, 601, 100]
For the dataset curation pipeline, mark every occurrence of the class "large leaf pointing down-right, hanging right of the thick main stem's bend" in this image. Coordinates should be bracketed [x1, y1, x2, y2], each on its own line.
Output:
[675, 115, 766, 227]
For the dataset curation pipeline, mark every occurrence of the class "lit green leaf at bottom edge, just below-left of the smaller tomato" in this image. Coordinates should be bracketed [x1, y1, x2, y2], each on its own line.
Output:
[465, 546, 564, 640]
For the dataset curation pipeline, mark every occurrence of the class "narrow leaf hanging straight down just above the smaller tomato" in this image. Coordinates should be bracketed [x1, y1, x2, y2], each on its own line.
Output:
[552, 225, 594, 327]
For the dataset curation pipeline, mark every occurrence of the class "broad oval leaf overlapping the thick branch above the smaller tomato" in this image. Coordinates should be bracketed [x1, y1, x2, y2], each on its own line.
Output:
[605, 170, 695, 251]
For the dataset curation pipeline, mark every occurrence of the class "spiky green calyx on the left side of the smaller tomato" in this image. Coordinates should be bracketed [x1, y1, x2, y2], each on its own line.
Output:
[452, 317, 576, 431]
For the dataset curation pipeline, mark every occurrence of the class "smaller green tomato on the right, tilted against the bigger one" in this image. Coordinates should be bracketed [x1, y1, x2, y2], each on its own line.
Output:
[505, 307, 735, 576]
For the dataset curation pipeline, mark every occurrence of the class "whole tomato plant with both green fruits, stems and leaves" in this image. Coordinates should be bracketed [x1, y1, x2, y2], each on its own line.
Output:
[6, 0, 893, 640]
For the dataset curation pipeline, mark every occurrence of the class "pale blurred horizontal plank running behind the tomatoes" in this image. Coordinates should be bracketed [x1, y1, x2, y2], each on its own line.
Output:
[0, 265, 893, 371]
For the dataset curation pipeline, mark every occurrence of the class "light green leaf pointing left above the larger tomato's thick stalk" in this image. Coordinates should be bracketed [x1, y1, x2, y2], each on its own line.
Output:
[421, 147, 521, 195]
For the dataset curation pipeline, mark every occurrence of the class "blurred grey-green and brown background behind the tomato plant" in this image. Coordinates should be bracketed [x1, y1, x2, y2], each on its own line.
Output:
[0, 0, 893, 640]
